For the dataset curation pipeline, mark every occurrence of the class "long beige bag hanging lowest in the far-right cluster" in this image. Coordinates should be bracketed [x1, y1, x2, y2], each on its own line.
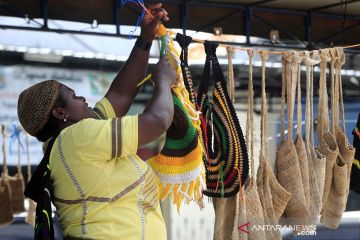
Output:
[320, 48, 355, 229]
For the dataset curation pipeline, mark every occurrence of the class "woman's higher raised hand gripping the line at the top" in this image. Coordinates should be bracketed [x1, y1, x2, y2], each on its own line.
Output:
[140, 3, 169, 42]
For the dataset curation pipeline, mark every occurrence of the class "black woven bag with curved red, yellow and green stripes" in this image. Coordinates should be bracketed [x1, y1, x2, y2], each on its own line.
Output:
[197, 41, 249, 197]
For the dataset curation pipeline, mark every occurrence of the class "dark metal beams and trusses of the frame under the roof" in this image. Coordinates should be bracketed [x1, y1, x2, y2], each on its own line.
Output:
[0, 0, 360, 53]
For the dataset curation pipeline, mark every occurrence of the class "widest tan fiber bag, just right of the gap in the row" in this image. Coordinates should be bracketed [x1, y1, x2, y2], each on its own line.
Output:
[276, 52, 309, 225]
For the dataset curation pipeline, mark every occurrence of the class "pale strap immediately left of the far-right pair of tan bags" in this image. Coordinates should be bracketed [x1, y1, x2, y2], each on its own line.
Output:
[304, 51, 320, 145]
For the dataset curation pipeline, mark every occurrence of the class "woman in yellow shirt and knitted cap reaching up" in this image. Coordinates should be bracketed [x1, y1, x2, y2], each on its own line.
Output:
[18, 4, 176, 239]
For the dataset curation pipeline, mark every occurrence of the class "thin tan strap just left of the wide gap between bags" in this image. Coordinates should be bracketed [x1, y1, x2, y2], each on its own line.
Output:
[259, 51, 269, 161]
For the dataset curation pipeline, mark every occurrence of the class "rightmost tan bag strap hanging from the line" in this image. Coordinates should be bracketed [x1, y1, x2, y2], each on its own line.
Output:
[335, 47, 345, 132]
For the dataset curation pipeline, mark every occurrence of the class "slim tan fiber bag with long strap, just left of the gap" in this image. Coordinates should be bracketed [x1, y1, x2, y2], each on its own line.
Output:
[256, 51, 281, 240]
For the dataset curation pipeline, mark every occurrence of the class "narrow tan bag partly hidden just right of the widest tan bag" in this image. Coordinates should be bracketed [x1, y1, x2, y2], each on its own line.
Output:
[295, 53, 310, 209]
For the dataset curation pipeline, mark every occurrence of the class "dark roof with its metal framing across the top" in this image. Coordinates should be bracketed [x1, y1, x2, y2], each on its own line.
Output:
[0, 0, 360, 51]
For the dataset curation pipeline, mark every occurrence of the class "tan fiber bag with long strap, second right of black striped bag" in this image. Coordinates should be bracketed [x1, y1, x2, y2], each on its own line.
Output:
[243, 50, 265, 240]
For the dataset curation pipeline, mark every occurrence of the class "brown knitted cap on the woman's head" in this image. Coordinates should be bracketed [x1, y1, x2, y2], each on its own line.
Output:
[17, 80, 61, 136]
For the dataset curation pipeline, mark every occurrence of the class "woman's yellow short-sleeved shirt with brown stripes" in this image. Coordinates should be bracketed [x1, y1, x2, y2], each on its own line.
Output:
[50, 98, 166, 240]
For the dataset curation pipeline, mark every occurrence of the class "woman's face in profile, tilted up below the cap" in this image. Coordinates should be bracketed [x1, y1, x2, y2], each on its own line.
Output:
[61, 85, 96, 123]
